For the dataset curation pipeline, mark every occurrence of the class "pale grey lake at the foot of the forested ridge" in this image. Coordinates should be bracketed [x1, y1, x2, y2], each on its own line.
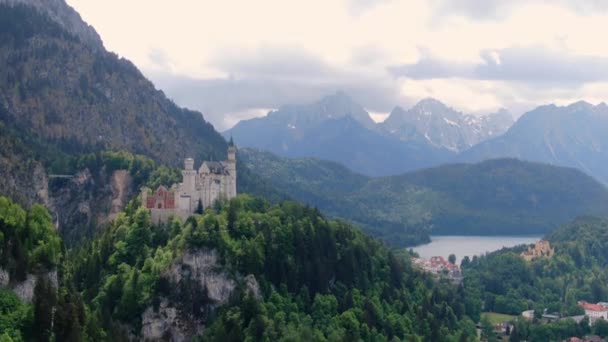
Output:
[412, 235, 542, 264]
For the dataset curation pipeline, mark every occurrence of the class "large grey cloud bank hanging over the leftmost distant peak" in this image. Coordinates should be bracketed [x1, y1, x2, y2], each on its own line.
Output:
[146, 47, 412, 130]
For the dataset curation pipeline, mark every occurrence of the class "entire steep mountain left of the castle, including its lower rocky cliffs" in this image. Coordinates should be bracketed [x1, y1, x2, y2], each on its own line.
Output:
[0, 0, 280, 241]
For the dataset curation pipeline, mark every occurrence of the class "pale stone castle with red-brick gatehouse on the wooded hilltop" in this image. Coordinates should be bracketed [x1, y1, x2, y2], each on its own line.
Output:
[141, 144, 236, 223]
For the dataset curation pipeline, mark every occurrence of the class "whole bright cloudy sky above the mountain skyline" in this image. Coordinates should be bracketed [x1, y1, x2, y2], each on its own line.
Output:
[67, 0, 608, 130]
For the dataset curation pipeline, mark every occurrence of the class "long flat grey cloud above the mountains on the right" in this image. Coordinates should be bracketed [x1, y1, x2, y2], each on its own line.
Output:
[389, 47, 608, 85]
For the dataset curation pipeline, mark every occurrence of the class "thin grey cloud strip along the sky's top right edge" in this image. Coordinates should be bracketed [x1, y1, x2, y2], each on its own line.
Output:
[431, 0, 608, 20]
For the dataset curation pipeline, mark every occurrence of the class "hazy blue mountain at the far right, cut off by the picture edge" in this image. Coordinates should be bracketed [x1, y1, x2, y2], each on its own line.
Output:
[458, 101, 608, 183]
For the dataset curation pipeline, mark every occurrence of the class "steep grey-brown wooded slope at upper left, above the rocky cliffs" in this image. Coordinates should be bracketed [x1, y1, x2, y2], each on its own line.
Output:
[0, 4, 226, 165]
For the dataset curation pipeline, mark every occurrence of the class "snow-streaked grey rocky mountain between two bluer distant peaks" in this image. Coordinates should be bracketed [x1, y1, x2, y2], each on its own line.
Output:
[380, 98, 513, 152]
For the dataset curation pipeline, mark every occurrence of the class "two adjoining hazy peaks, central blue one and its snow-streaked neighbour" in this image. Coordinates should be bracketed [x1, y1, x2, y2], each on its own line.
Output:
[224, 92, 512, 176]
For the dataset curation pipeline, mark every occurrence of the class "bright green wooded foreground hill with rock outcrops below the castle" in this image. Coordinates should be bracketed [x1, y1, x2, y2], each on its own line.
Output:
[0, 196, 478, 341]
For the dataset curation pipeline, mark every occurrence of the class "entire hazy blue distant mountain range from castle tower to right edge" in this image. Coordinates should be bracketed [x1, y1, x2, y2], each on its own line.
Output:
[224, 92, 608, 183]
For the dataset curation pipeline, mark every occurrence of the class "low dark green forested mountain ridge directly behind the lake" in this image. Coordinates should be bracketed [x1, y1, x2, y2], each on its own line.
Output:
[239, 149, 608, 246]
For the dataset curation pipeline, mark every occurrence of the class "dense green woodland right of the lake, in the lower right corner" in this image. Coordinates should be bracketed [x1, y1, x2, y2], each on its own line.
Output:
[462, 217, 608, 341]
